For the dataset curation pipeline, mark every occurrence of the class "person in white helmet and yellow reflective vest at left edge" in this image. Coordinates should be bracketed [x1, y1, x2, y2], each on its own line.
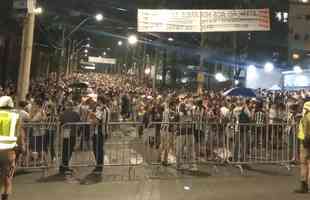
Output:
[0, 96, 24, 200]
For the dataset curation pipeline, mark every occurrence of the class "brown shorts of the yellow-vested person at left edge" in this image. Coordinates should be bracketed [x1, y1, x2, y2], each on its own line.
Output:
[0, 150, 16, 178]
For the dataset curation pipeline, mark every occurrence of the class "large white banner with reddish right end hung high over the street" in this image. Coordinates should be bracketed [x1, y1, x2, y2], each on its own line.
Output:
[138, 9, 270, 32]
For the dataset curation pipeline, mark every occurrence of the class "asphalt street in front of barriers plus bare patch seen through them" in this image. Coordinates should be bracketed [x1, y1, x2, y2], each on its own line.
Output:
[11, 126, 310, 200]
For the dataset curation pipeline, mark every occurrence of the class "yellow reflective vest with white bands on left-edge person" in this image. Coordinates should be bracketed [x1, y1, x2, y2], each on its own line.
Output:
[0, 110, 19, 150]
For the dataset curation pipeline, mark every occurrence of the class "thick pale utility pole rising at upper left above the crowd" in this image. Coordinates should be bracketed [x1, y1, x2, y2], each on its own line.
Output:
[17, 1, 36, 101]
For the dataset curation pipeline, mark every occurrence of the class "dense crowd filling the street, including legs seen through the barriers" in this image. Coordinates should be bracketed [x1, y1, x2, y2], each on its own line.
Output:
[0, 73, 310, 195]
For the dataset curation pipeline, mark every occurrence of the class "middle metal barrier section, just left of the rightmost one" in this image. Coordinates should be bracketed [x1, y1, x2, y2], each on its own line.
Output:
[145, 122, 229, 170]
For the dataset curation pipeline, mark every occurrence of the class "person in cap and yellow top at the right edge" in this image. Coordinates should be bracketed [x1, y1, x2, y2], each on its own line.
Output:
[295, 101, 310, 193]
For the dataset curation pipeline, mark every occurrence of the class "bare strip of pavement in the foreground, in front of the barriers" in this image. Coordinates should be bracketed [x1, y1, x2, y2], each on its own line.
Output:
[11, 166, 310, 200]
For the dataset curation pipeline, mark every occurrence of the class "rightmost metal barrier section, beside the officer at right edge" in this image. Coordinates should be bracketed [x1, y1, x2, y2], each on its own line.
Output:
[227, 124, 297, 168]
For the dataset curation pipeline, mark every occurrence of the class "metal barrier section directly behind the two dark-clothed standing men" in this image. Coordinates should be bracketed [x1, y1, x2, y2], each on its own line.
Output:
[60, 122, 144, 178]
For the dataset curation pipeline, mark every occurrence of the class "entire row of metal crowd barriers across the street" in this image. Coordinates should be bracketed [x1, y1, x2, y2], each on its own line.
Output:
[17, 122, 298, 176]
